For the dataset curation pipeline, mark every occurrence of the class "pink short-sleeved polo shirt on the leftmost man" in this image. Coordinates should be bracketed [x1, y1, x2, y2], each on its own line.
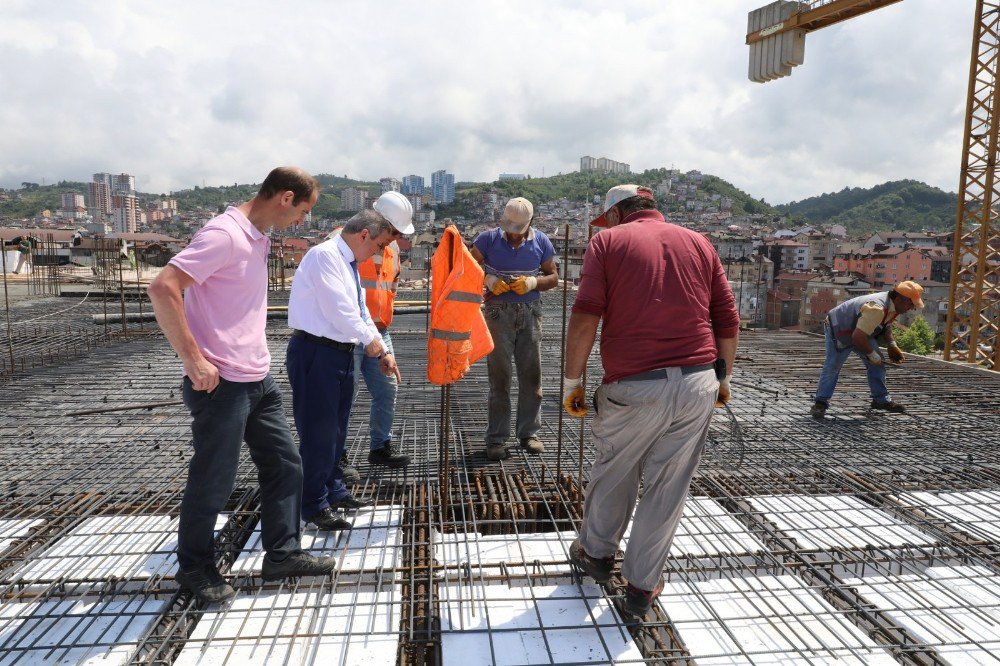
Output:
[170, 206, 271, 382]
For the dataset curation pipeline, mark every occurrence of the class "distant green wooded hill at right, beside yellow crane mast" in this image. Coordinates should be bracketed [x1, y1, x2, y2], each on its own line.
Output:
[776, 180, 958, 235]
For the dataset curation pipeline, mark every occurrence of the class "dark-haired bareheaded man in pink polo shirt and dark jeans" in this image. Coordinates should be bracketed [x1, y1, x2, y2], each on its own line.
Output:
[149, 167, 336, 603]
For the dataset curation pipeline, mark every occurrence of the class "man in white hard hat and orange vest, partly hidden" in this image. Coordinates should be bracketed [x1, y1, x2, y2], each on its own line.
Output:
[327, 191, 414, 474]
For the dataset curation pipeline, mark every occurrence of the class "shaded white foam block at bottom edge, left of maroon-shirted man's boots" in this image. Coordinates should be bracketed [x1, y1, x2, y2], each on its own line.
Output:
[438, 583, 642, 666]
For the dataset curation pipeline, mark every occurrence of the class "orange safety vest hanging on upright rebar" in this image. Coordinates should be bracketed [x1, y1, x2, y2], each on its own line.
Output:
[427, 224, 493, 385]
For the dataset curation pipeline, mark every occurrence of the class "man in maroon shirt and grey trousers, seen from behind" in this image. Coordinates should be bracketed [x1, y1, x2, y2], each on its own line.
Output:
[563, 185, 739, 617]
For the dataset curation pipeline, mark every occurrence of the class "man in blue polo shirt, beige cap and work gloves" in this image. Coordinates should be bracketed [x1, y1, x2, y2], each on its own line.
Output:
[472, 197, 559, 460]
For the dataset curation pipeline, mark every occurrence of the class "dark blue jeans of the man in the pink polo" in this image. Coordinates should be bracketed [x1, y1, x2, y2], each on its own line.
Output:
[177, 375, 302, 571]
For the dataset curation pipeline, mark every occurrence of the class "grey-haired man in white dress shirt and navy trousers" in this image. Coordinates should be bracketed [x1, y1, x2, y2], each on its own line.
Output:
[285, 210, 399, 530]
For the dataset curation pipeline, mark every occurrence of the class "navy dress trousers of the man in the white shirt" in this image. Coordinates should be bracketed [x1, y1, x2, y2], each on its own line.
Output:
[285, 336, 354, 518]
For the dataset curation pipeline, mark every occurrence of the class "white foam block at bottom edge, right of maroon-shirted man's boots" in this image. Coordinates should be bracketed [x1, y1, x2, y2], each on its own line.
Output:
[659, 576, 896, 666]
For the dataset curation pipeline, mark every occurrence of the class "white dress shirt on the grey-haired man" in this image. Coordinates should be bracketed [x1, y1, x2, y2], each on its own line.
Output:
[288, 236, 382, 346]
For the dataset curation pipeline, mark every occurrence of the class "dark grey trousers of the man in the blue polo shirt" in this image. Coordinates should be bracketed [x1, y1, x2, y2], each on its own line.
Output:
[485, 300, 542, 444]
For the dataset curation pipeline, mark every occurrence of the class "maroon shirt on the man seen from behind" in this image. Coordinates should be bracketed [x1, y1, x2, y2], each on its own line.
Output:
[573, 210, 740, 384]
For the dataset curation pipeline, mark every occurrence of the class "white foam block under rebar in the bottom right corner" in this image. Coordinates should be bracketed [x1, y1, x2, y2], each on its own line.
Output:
[844, 567, 1000, 664]
